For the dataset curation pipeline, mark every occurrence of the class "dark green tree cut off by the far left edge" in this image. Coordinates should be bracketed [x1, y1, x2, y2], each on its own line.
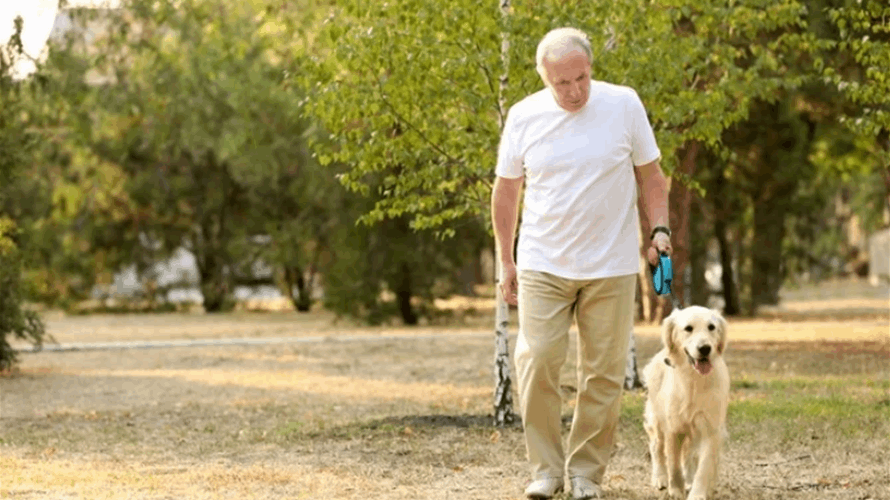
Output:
[0, 17, 46, 371]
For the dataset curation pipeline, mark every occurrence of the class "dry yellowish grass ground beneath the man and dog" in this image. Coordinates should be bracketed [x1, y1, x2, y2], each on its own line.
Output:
[0, 300, 890, 500]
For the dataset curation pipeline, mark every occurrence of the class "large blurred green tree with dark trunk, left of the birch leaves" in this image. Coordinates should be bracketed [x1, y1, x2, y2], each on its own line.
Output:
[44, 0, 332, 312]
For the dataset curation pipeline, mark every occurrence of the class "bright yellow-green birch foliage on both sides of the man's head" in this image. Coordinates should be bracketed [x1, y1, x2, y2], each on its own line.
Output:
[302, 0, 816, 230]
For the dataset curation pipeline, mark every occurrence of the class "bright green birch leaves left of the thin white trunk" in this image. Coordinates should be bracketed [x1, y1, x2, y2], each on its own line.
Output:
[304, 2, 499, 233]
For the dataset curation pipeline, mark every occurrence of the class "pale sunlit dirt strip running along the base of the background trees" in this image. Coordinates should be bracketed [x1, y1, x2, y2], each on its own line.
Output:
[17, 298, 890, 348]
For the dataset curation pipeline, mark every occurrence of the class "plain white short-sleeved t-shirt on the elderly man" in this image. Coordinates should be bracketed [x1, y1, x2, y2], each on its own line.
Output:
[495, 80, 661, 279]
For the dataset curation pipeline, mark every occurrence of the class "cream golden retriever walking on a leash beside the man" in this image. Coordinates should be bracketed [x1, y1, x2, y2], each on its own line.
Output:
[643, 306, 729, 500]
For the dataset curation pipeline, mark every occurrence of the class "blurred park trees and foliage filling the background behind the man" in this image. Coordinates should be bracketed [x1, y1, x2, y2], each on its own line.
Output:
[0, 0, 890, 339]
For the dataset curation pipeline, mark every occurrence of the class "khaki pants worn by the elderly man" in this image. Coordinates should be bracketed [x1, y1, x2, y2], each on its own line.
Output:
[515, 271, 637, 484]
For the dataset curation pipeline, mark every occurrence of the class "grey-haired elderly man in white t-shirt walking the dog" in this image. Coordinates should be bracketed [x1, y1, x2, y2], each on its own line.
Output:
[492, 28, 671, 499]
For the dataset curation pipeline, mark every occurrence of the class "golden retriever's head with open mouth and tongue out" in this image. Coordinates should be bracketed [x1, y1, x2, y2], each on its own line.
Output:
[661, 306, 726, 375]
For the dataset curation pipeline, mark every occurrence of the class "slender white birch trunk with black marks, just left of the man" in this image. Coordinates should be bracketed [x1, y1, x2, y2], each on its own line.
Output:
[494, 0, 516, 427]
